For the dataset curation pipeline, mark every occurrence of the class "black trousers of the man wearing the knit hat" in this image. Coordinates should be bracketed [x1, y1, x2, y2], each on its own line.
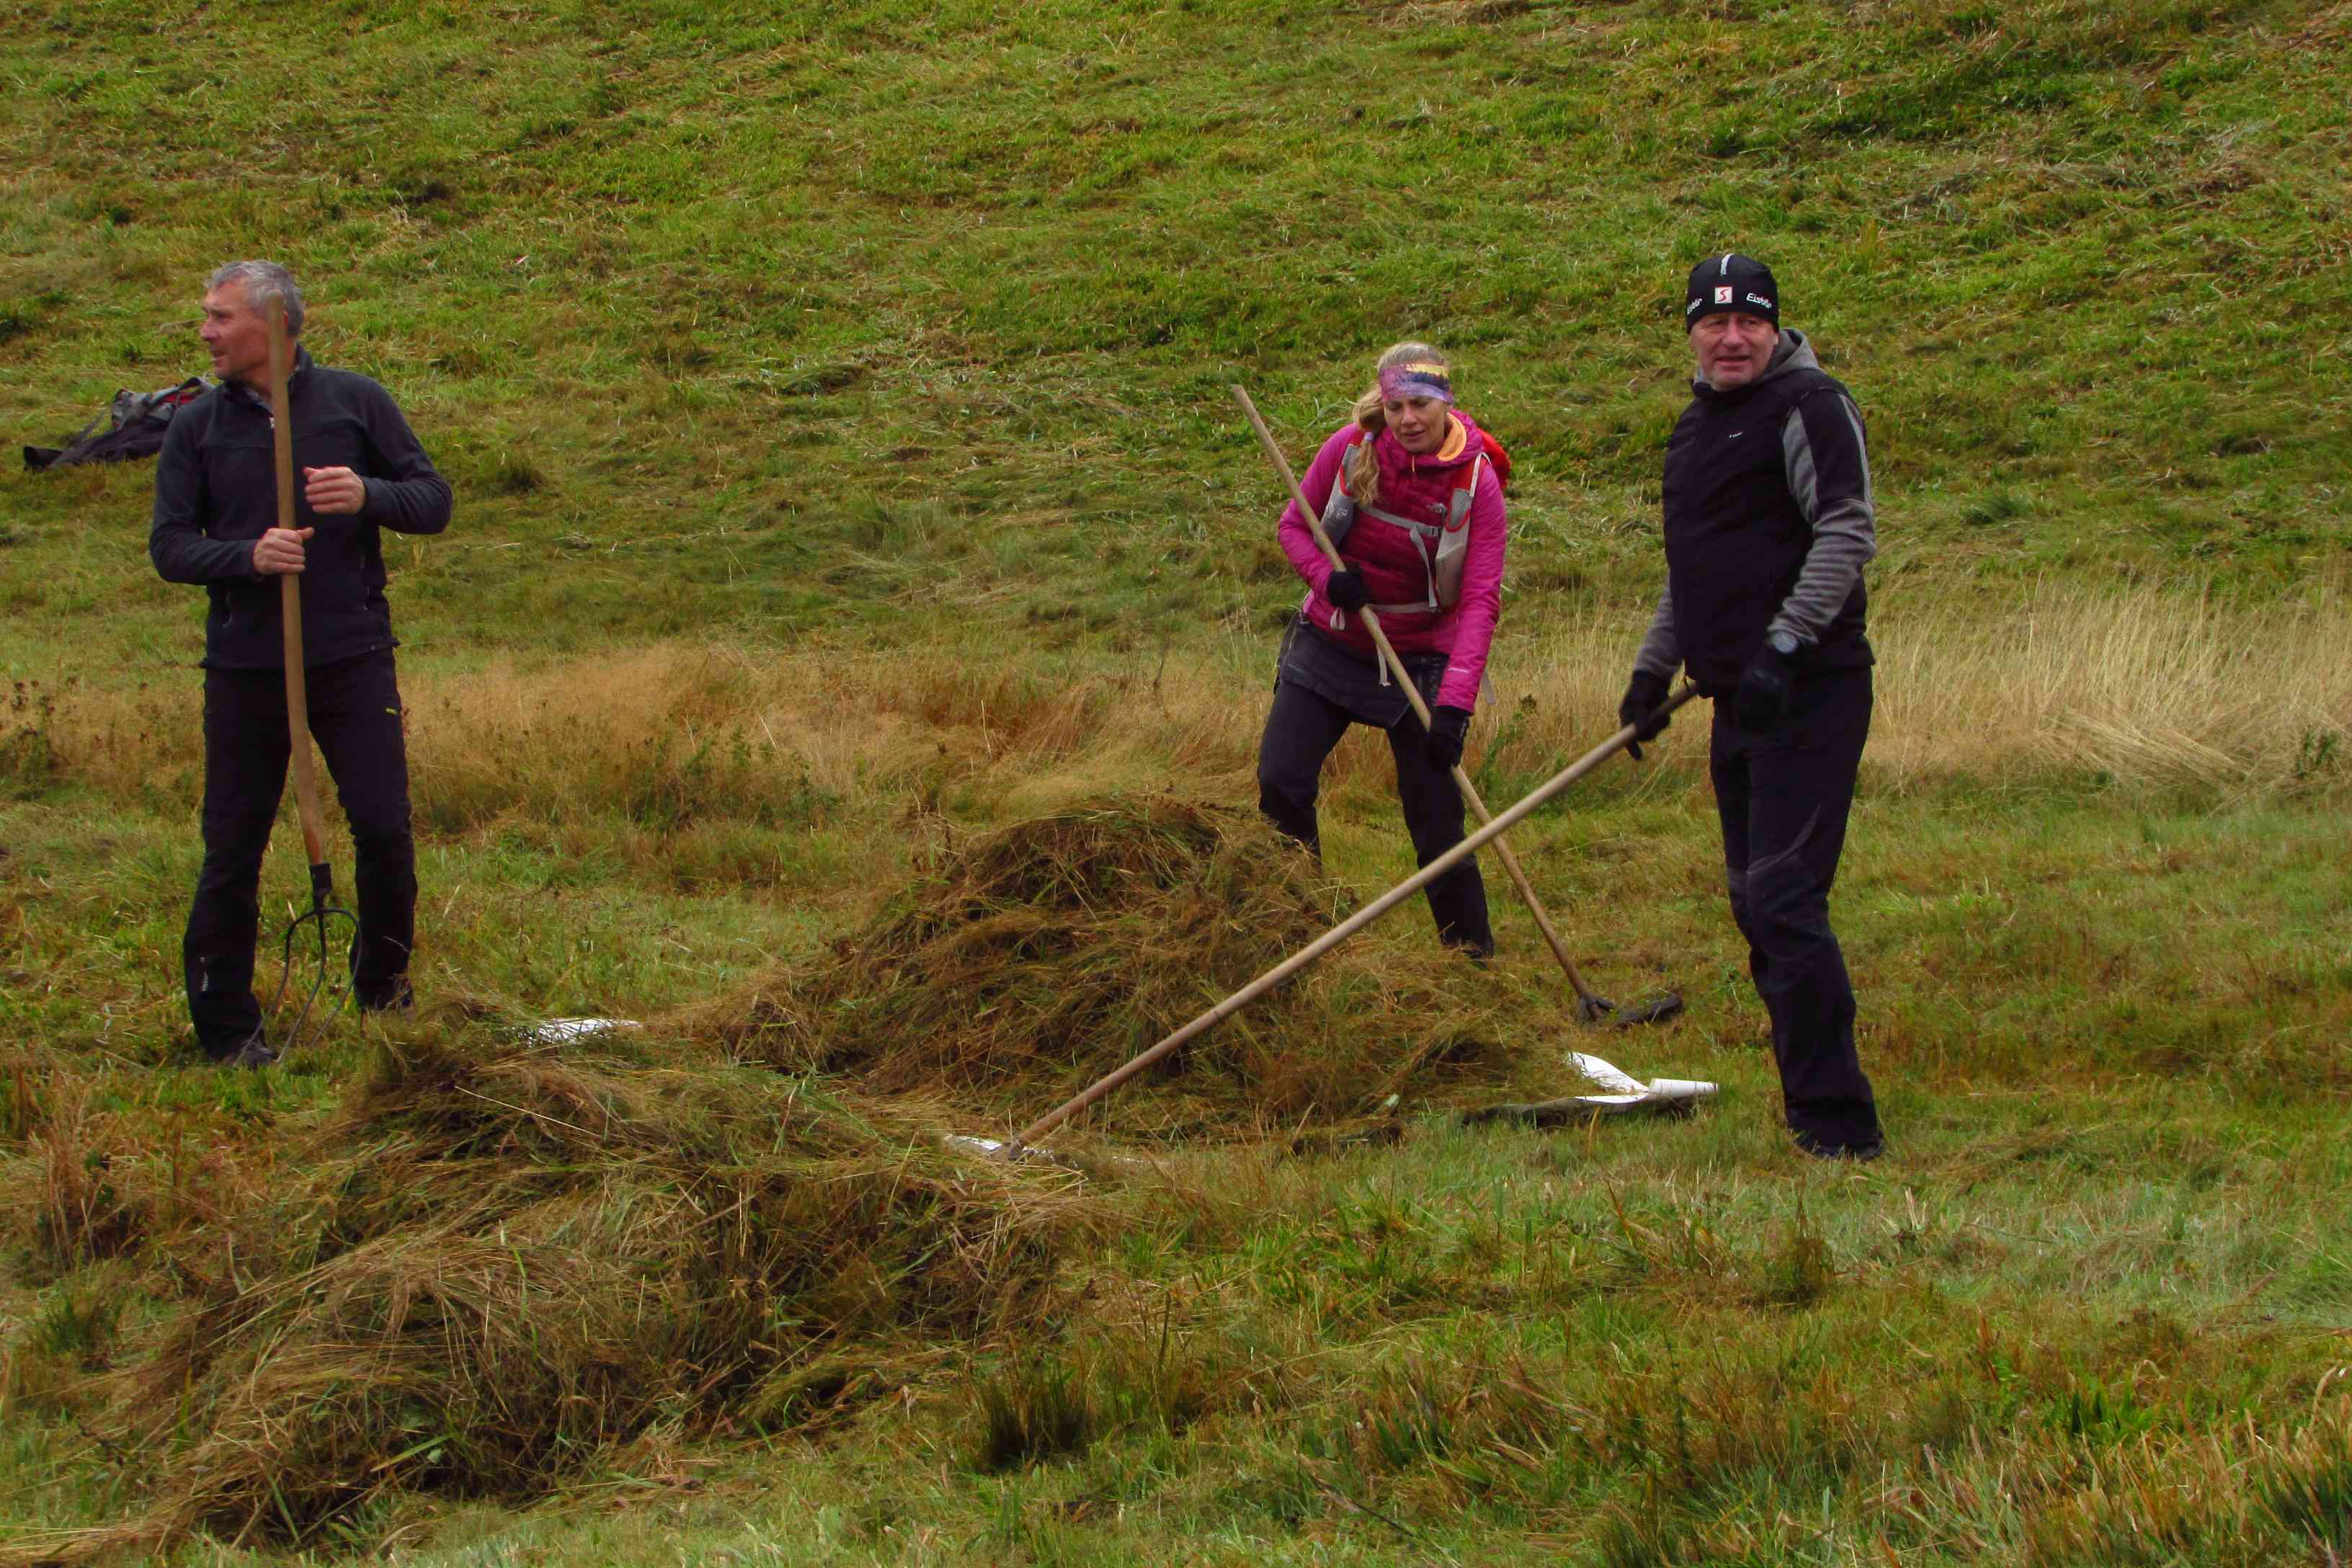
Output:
[1708, 668, 1879, 1152]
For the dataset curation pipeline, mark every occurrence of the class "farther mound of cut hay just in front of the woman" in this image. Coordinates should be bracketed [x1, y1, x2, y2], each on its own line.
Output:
[673, 797, 1494, 1136]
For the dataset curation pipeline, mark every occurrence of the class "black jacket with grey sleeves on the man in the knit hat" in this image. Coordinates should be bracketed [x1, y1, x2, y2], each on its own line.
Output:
[1634, 329, 1877, 696]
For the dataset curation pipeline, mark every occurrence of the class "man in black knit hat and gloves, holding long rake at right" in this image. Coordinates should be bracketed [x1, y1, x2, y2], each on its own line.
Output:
[1618, 254, 1881, 1159]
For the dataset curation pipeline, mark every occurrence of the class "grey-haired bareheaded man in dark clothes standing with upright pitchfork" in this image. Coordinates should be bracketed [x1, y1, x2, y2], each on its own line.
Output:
[148, 261, 449, 1067]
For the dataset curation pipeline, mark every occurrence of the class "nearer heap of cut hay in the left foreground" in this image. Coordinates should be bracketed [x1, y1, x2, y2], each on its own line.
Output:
[0, 1046, 1096, 1563]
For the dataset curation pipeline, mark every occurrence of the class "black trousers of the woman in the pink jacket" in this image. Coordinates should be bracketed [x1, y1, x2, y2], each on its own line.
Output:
[1258, 682, 1494, 957]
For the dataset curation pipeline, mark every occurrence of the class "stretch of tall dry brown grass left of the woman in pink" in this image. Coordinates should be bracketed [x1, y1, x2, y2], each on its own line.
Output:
[27, 642, 1263, 832]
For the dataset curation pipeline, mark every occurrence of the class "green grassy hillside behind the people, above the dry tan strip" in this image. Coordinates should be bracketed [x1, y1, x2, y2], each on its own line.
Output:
[0, 0, 2345, 654]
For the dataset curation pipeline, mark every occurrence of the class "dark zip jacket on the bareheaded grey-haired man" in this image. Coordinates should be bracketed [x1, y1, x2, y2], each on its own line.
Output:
[148, 350, 449, 670]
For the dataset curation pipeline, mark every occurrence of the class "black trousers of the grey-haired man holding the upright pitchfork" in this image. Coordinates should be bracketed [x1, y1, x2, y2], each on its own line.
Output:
[181, 649, 416, 1056]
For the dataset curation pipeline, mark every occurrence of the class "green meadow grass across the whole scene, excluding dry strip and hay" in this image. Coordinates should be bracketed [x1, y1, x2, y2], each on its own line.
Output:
[0, 0, 2352, 1563]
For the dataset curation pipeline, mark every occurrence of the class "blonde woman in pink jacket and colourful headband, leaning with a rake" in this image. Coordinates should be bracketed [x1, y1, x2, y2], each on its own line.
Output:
[1258, 343, 1507, 957]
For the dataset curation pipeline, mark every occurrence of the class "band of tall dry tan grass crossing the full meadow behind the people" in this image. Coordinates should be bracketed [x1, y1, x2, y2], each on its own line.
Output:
[22, 579, 2352, 837]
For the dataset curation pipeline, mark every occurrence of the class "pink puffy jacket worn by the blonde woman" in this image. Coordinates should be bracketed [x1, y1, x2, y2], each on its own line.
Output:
[1282, 409, 1507, 710]
